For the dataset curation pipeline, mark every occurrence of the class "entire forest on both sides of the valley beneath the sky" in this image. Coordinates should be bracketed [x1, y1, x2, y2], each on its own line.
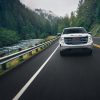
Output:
[0, 0, 100, 47]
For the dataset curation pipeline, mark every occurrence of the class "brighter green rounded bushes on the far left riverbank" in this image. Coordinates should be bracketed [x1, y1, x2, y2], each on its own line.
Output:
[0, 28, 19, 47]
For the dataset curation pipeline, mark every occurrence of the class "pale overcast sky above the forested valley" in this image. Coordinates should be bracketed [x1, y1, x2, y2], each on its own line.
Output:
[20, 0, 79, 16]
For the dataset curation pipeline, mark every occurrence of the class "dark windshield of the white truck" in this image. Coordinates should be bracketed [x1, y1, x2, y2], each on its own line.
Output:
[63, 28, 87, 34]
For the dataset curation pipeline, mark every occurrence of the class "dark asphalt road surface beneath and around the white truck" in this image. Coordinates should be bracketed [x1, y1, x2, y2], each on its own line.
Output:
[0, 38, 100, 100]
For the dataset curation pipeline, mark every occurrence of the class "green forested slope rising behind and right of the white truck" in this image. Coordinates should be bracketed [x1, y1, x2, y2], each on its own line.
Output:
[59, 0, 100, 36]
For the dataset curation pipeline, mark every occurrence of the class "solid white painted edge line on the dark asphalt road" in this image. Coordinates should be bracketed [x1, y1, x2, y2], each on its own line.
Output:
[12, 45, 59, 100]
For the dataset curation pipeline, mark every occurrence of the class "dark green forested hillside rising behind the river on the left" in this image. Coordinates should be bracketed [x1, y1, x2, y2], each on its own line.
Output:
[0, 0, 58, 47]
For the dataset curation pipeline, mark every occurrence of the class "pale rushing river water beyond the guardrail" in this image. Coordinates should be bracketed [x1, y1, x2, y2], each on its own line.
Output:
[0, 39, 43, 57]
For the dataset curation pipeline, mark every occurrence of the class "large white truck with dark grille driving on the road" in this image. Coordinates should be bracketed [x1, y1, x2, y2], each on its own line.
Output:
[59, 27, 93, 56]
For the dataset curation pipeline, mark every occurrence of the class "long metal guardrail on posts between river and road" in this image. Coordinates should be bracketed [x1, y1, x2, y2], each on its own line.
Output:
[0, 38, 57, 70]
